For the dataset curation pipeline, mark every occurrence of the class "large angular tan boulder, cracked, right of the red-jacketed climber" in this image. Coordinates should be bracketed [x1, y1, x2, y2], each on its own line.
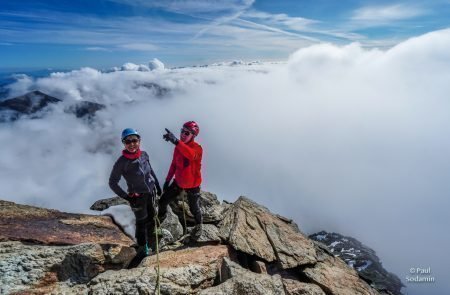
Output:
[219, 197, 317, 269]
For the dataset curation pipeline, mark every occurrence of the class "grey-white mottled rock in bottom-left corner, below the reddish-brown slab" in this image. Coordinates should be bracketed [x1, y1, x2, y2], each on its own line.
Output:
[0, 242, 136, 294]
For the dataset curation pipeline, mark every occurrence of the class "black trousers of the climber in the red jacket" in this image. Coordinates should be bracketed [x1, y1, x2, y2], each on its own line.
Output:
[159, 181, 203, 224]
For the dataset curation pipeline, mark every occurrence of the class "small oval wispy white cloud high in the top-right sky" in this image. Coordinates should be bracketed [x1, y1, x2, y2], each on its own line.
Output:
[352, 4, 426, 25]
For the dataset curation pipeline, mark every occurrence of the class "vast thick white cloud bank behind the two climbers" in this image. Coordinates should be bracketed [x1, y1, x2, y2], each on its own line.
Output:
[0, 30, 450, 294]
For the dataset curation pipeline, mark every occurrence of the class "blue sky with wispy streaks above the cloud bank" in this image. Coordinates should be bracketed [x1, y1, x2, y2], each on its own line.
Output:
[0, 0, 450, 70]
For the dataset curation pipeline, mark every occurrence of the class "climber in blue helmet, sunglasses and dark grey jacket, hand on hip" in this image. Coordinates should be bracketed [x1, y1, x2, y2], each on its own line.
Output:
[109, 128, 161, 255]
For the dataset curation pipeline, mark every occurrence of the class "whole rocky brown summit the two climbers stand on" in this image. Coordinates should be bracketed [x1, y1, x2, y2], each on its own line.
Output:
[0, 192, 398, 295]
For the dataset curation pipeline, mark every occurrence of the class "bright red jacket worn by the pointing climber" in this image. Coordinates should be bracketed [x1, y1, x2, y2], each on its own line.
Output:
[166, 140, 203, 188]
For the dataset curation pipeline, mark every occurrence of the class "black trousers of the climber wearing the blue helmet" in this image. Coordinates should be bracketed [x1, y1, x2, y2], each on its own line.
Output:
[130, 193, 155, 246]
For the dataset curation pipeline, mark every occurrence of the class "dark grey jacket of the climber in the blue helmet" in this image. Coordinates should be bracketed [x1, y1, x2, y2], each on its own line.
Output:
[109, 151, 159, 199]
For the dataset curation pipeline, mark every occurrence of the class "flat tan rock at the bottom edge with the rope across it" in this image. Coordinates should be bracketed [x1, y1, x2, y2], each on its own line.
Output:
[89, 245, 234, 294]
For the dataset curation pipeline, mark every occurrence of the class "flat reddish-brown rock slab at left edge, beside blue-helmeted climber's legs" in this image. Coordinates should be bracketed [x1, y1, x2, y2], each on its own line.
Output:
[0, 200, 134, 247]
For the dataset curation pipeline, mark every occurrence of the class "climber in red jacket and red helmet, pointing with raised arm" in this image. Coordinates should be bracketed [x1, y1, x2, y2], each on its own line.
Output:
[159, 121, 203, 232]
